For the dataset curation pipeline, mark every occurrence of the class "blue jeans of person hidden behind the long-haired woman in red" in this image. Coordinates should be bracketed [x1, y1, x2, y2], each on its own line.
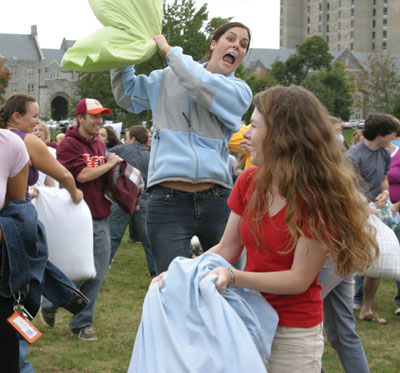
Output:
[318, 261, 369, 373]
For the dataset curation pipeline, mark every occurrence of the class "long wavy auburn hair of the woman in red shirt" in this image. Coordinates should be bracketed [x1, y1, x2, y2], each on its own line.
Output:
[246, 86, 379, 276]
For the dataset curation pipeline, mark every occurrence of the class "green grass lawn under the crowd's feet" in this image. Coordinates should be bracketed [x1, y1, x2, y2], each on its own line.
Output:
[28, 231, 400, 373]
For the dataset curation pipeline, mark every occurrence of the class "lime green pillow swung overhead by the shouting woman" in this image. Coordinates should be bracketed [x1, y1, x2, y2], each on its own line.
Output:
[61, 0, 163, 72]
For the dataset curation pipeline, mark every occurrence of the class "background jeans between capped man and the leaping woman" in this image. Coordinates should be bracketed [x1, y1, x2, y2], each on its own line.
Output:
[109, 198, 156, 277]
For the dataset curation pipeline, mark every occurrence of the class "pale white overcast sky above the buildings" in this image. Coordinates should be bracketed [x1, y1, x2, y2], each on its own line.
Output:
[0, 0, 279, 49]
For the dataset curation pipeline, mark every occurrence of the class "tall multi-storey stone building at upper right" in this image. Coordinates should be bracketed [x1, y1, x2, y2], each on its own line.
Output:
[280, 0, 400, 53]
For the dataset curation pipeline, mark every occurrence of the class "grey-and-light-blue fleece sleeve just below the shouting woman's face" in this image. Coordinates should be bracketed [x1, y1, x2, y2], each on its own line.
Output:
[167, 47, 253, 132]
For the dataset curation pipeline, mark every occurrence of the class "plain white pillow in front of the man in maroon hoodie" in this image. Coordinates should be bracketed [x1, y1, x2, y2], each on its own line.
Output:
[33, 186, 96, 281]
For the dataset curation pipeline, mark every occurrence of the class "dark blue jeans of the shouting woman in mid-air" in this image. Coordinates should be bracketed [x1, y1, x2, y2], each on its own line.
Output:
[146, 185, 231, 273]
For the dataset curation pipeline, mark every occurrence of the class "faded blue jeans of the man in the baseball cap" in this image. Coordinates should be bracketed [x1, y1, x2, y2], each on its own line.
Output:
[42, 219, 111, 331]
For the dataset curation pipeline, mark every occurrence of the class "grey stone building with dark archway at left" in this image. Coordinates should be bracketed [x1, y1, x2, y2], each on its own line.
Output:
[0, 26, 79, 120]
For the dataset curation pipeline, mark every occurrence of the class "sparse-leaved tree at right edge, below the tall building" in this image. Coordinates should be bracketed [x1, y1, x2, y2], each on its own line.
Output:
[354, 53, 400, 116]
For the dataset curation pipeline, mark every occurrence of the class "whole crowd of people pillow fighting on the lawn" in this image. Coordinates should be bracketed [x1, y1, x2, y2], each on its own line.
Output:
[0, 22, 400, 373]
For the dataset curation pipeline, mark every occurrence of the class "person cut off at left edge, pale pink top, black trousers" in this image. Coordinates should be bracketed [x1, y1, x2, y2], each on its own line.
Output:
[0, 129, 29, 373]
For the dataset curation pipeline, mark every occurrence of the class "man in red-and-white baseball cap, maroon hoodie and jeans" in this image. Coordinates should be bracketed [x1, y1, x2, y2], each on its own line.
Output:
[41, 98, 121, 340]
